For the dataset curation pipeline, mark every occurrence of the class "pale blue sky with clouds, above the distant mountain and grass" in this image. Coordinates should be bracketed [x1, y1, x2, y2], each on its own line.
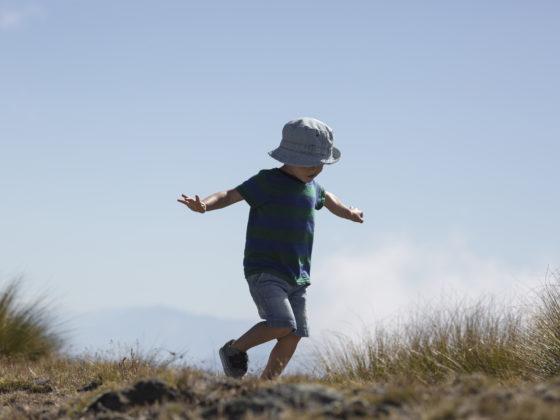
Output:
[0, 0, 560, 334]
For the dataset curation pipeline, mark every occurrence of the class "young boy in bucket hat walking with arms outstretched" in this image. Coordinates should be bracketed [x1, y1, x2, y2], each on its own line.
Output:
[177, 118, 363, 379]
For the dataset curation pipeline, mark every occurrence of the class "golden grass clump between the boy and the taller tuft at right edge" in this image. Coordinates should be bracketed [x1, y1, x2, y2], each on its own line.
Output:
[317, 300, 525, 383]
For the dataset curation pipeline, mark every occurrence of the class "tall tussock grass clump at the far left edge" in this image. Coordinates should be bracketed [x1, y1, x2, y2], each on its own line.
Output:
[0, 279, 63, 359]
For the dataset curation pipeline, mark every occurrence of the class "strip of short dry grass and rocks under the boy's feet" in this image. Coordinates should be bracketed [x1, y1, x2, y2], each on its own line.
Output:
[0, 355, 560, 420]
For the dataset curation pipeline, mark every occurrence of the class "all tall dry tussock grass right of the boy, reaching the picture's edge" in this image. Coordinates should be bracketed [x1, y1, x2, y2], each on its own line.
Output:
[315, 271, 560, 384]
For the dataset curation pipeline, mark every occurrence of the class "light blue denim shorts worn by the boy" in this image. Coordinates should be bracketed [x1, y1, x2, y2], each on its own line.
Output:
[247, 273, 309, 337]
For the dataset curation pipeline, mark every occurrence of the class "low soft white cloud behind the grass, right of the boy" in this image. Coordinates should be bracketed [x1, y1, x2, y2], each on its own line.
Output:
[309, 240, 546, 335]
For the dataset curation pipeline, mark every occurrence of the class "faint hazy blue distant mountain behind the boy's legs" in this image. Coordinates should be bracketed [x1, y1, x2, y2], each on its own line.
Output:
[63, 306, 280, 370]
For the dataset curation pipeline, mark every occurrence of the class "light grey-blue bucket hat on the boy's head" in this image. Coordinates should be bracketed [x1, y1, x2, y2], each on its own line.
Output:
[268, 118, 341, 166]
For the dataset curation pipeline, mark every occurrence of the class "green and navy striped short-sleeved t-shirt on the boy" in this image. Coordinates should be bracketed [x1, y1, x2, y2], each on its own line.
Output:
[237, 169, 325, 285]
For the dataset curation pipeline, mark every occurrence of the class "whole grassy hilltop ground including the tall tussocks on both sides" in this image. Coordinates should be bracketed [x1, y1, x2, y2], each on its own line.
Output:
[0, 278, 560, 420]
